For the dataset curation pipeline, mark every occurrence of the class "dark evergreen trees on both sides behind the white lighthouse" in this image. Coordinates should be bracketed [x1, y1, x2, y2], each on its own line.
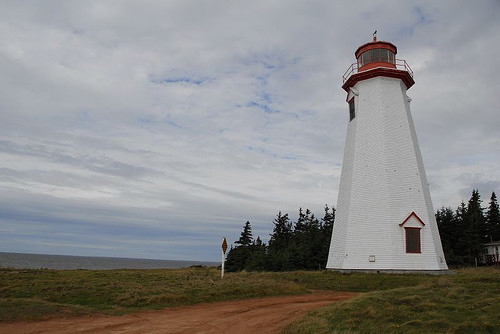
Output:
[226, 189, 500, 271]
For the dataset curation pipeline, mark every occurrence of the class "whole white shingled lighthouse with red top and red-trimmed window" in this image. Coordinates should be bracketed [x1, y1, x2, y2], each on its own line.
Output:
[326, 35, 448, 272]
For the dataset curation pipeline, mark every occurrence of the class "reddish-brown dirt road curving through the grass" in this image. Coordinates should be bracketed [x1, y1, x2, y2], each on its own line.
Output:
[0, 291, 356, 334]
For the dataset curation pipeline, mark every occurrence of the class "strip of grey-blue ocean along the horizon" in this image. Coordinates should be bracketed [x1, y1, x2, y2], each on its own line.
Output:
[0, 252, 219, 270]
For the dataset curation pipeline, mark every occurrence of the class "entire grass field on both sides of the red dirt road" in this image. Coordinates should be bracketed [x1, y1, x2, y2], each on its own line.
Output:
[0, 268, 500, 333]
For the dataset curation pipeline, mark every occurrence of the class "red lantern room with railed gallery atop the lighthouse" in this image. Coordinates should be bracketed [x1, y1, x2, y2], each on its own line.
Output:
[342, 32, 415, 92]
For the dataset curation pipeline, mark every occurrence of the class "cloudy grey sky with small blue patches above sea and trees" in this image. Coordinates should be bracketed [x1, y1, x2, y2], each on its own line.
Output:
[0, 0, 500, 261]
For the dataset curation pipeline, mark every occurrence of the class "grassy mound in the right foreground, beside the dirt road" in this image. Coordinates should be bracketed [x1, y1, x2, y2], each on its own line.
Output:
[284, 268, 500, 334]
